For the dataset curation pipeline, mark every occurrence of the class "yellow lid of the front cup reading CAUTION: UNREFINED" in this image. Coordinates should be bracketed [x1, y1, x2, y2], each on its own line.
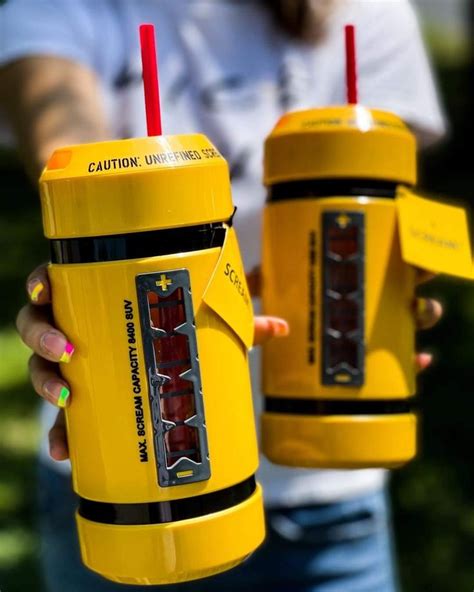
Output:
[40, 134, 234, 238]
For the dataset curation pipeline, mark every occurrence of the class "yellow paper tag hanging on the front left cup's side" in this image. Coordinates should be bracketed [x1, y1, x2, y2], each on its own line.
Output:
[203, 228, 254, 348]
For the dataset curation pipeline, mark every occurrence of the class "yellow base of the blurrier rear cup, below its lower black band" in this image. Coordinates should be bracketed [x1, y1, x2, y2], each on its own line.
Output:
[262, 413, 417, 469]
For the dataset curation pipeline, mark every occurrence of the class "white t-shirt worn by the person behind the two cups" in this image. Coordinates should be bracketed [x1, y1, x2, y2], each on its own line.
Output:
[0, 0, 444, 506]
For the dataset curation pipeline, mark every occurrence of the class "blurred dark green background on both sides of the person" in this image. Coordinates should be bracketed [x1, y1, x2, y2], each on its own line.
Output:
[0, 55, 474, 592]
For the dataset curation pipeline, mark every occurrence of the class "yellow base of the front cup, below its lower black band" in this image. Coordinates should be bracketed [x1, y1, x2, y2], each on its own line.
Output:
[77, 486, 265, 589]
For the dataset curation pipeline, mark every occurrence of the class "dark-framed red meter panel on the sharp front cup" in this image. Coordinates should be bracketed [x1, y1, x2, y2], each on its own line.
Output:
[136, 269, 210, 487]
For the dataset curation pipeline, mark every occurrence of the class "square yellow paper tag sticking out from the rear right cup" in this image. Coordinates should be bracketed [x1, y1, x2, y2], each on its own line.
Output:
[397, 189, 474, 279]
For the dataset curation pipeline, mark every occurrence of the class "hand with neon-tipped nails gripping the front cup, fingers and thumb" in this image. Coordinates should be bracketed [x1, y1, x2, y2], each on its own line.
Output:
[16, 265, 288, 460]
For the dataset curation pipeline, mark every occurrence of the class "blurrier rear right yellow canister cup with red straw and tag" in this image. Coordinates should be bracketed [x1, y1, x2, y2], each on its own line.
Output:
[262, 27, 472, 468]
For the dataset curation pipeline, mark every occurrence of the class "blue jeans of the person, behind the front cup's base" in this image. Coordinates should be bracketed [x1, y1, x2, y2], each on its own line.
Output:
[39, 467, 397, 592]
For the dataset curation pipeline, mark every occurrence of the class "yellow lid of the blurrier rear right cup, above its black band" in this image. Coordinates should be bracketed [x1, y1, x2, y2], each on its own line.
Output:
[264, 105, 416, 185]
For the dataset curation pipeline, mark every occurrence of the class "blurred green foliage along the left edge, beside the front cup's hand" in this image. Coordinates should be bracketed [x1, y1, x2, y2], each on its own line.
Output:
[0, 165, 47, 592]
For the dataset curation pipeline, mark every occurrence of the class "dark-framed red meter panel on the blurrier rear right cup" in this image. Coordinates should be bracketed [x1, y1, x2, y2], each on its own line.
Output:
[322, 212, 365, 386]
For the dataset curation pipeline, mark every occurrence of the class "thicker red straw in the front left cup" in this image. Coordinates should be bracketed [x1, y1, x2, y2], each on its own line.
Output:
[140, 25, 161, 136]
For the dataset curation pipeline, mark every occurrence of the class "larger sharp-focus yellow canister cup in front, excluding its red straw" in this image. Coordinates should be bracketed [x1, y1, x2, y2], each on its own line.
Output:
[40, 25, 264, 584]
